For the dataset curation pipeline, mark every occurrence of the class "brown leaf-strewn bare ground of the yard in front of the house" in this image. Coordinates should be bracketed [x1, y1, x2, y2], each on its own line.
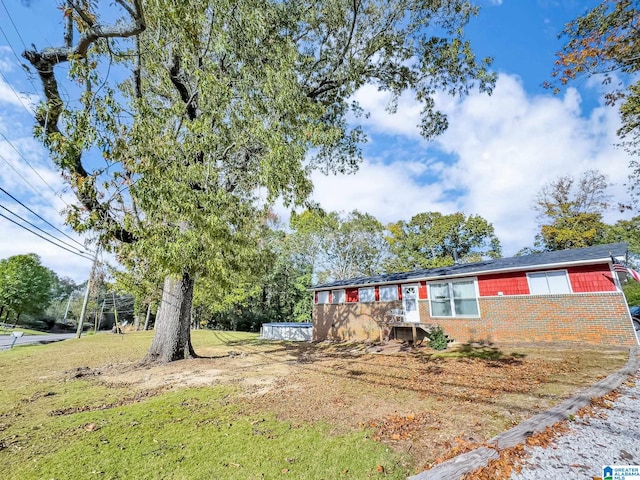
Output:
[100, 342, 628, 471]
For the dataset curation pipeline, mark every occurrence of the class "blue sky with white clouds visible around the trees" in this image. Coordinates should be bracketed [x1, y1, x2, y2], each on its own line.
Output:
[0, 0, 629, 281]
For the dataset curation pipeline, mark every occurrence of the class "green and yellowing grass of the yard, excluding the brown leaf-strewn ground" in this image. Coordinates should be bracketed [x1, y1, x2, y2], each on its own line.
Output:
[0, 331, 411, 479]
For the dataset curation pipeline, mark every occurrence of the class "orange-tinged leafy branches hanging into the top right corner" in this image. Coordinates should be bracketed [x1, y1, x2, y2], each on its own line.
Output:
[547, 0, 640, 200]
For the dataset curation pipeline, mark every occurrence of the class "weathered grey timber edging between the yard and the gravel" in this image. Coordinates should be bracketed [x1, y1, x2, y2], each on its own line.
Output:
[408, 347, 640, 480]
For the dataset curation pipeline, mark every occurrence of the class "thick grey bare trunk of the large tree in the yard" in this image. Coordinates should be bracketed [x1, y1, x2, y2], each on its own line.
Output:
[142, 271, 197, 363]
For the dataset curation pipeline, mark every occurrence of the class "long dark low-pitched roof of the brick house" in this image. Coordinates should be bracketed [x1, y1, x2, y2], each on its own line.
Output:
[311, 242, 627, 290]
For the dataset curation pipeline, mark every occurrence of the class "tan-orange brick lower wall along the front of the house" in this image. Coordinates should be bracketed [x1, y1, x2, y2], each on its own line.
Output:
[313, 292, 637, 347]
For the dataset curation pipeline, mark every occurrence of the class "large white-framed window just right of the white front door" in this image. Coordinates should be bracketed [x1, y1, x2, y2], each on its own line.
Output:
[429, 280, 479, 317]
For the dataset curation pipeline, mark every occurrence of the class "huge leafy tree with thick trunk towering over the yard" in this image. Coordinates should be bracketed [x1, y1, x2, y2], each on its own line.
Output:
[24, 0, 495, 362]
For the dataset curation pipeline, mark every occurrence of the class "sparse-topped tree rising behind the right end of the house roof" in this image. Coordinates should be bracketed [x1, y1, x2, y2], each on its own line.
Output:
[533, 170, 610, 251]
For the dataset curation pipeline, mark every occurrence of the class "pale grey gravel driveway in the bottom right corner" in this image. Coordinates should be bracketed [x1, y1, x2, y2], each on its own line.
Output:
[510, 374, 640, 480]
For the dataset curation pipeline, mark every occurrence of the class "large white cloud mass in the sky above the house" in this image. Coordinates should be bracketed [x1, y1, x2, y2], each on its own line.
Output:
[314, 75, 629, 255]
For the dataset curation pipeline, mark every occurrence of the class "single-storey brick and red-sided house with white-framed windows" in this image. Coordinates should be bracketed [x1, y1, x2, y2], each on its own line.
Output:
[312, 243, 638, 347]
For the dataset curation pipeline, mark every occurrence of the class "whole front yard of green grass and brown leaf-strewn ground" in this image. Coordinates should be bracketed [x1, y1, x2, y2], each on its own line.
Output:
[0, 331, 628, 479]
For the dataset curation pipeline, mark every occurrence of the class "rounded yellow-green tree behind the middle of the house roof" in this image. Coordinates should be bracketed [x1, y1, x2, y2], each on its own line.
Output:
[386, 212, 501, 272]
